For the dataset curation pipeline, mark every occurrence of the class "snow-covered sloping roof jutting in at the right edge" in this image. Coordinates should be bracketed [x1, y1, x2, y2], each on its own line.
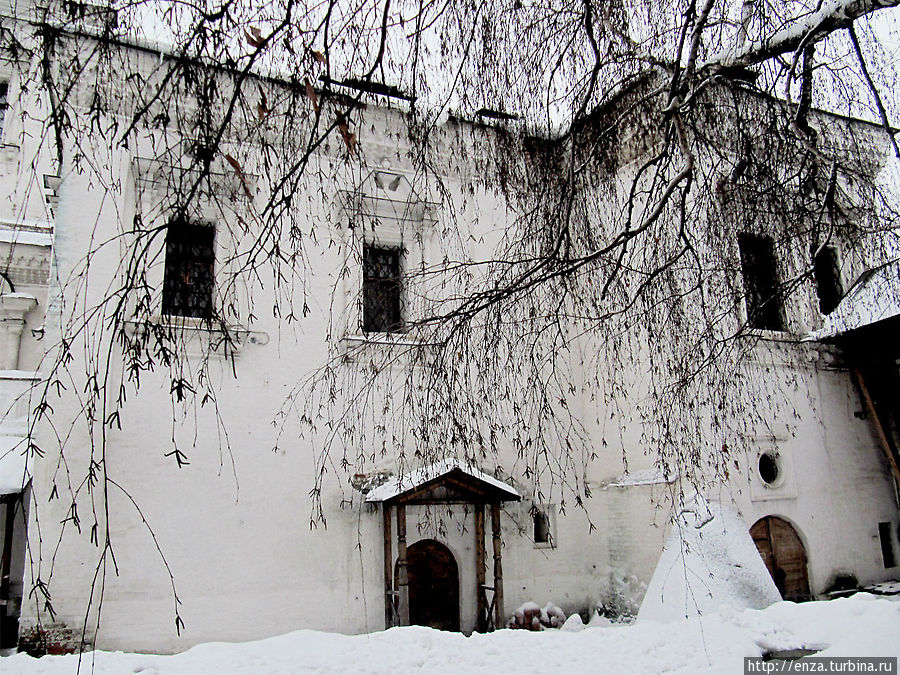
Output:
[807, 261, 900, 340]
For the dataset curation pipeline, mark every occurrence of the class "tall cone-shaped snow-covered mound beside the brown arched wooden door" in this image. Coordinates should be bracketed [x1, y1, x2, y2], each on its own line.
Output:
[638, 497, 781, 622]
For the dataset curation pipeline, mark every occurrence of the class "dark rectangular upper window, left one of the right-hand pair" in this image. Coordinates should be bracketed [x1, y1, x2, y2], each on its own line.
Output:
[738, 233, 784, 330]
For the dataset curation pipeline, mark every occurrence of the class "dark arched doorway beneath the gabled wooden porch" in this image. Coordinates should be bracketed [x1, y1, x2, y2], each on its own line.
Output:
[394, 539, 459, 631]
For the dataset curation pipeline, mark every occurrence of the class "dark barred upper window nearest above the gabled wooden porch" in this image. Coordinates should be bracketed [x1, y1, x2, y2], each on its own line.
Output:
[363, 245, 403, 333]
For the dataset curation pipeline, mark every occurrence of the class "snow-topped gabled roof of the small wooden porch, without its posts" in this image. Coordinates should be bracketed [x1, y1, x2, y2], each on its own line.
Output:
[366, 459, 522, 504]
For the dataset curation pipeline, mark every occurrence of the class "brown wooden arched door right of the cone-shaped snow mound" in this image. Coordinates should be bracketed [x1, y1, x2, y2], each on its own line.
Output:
[750, 516, 810, 602]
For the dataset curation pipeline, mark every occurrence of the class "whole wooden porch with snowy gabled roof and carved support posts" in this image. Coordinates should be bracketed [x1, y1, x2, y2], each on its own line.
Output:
[366, 460, 521, 631]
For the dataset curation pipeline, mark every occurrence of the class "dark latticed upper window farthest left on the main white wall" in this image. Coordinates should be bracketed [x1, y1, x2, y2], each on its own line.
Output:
[162, 222, 216, 319]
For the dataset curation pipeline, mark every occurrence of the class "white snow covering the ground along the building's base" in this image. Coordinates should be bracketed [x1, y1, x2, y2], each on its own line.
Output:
[0, 593, 900, 675]
